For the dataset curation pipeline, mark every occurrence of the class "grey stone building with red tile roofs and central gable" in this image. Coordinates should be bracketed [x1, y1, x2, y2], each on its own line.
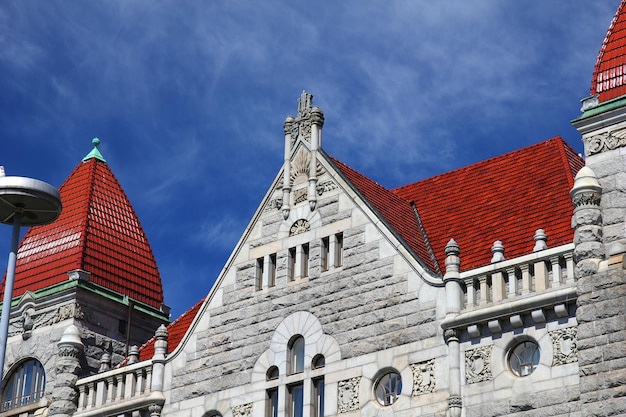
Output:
[1, 0, 626, 417]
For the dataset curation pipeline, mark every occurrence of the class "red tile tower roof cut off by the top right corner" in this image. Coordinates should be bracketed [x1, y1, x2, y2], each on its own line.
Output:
[591, 0, 626, 103]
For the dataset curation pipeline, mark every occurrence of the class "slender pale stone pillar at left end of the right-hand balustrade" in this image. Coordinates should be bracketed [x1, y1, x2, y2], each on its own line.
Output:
[443, 239, 463, 417]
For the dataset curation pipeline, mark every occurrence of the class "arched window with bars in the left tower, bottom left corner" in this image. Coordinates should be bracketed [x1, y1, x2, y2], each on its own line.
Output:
[2, 359, 46, 411]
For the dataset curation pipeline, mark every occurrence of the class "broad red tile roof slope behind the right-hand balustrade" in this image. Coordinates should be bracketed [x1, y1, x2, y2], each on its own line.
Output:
[393, 137, 584, 270]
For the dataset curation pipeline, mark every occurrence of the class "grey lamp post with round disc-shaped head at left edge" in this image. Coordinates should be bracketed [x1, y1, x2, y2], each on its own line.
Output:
[0, 171, 61, 378]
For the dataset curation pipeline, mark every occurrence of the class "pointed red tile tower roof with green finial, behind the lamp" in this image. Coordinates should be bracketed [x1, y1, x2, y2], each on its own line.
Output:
[2, 142, 163, 309]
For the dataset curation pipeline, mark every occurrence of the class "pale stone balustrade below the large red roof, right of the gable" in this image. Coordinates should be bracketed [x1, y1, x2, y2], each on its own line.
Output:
[460, 244, 575, 311]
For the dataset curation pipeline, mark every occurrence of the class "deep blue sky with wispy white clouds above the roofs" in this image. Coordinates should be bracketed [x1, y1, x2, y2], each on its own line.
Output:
[0, 0, 619, 318]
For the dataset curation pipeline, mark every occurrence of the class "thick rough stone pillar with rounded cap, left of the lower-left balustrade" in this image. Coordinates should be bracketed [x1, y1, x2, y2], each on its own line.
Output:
[48, 324, 83, 417]
